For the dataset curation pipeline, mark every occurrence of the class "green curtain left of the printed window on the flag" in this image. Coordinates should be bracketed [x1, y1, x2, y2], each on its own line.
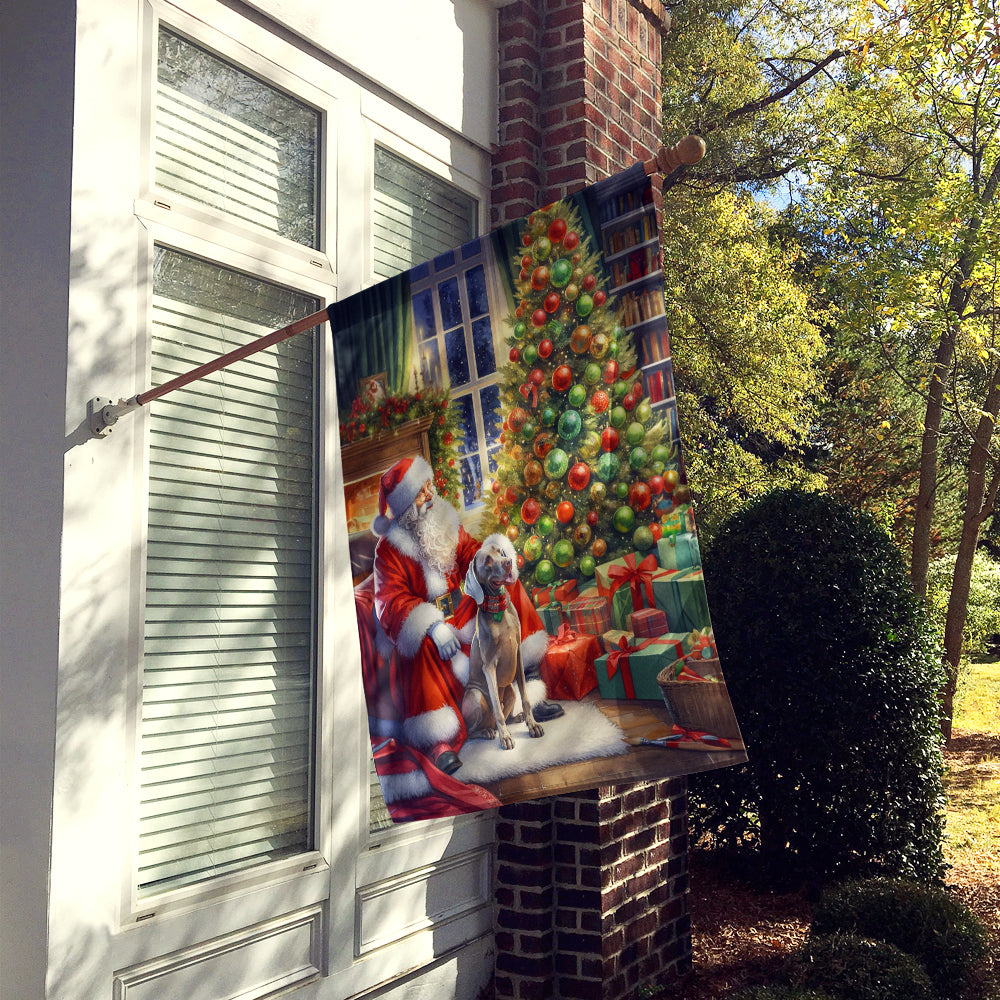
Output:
[329, 271, 413, 411]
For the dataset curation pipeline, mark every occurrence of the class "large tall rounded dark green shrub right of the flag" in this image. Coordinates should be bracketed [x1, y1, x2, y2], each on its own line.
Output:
[690, 490, 944, 880]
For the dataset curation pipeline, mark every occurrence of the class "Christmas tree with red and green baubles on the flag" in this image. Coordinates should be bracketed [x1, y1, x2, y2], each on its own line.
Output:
[480, 201, 677, 586]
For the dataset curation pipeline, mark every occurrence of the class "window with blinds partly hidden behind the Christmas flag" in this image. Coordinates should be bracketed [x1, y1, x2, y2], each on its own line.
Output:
[369, 145, 478, 833]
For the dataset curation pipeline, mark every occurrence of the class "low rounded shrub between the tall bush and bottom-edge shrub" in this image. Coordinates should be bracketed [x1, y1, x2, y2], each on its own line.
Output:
[812, 878, 987, 997]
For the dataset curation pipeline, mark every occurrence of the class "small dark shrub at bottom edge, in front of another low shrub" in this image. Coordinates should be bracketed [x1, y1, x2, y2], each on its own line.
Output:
[790, 934, 934, 1000]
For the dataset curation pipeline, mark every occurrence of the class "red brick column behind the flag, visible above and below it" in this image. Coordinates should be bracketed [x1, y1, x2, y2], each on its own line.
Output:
[492, 0, 691, 1000]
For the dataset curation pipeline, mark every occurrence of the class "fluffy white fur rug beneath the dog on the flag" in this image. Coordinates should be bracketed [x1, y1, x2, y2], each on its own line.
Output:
[452, 701, 628, 785]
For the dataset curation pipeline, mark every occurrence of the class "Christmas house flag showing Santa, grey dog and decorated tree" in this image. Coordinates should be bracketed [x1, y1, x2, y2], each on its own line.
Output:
[330, 165, 746, 820]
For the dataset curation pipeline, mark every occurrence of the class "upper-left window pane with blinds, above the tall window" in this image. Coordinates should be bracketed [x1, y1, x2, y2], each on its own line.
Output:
[154, 28, 320, 247]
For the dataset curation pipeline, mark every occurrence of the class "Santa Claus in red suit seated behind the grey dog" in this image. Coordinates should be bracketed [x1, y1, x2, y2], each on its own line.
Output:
[372, 456, 561, 774]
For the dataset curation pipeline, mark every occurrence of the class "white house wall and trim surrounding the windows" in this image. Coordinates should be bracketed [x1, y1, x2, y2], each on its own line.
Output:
[0, 0, 496, 1000]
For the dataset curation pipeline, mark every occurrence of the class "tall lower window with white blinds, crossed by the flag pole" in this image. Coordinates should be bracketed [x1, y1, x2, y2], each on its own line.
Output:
[138, 248, 318, 895]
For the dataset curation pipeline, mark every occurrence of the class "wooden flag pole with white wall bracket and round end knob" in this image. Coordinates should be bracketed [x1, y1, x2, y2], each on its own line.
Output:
[87, 135, 705, 437]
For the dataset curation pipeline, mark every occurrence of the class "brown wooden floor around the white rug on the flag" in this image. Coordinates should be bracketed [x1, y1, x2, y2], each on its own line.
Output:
[483, 695, 746, 803]
